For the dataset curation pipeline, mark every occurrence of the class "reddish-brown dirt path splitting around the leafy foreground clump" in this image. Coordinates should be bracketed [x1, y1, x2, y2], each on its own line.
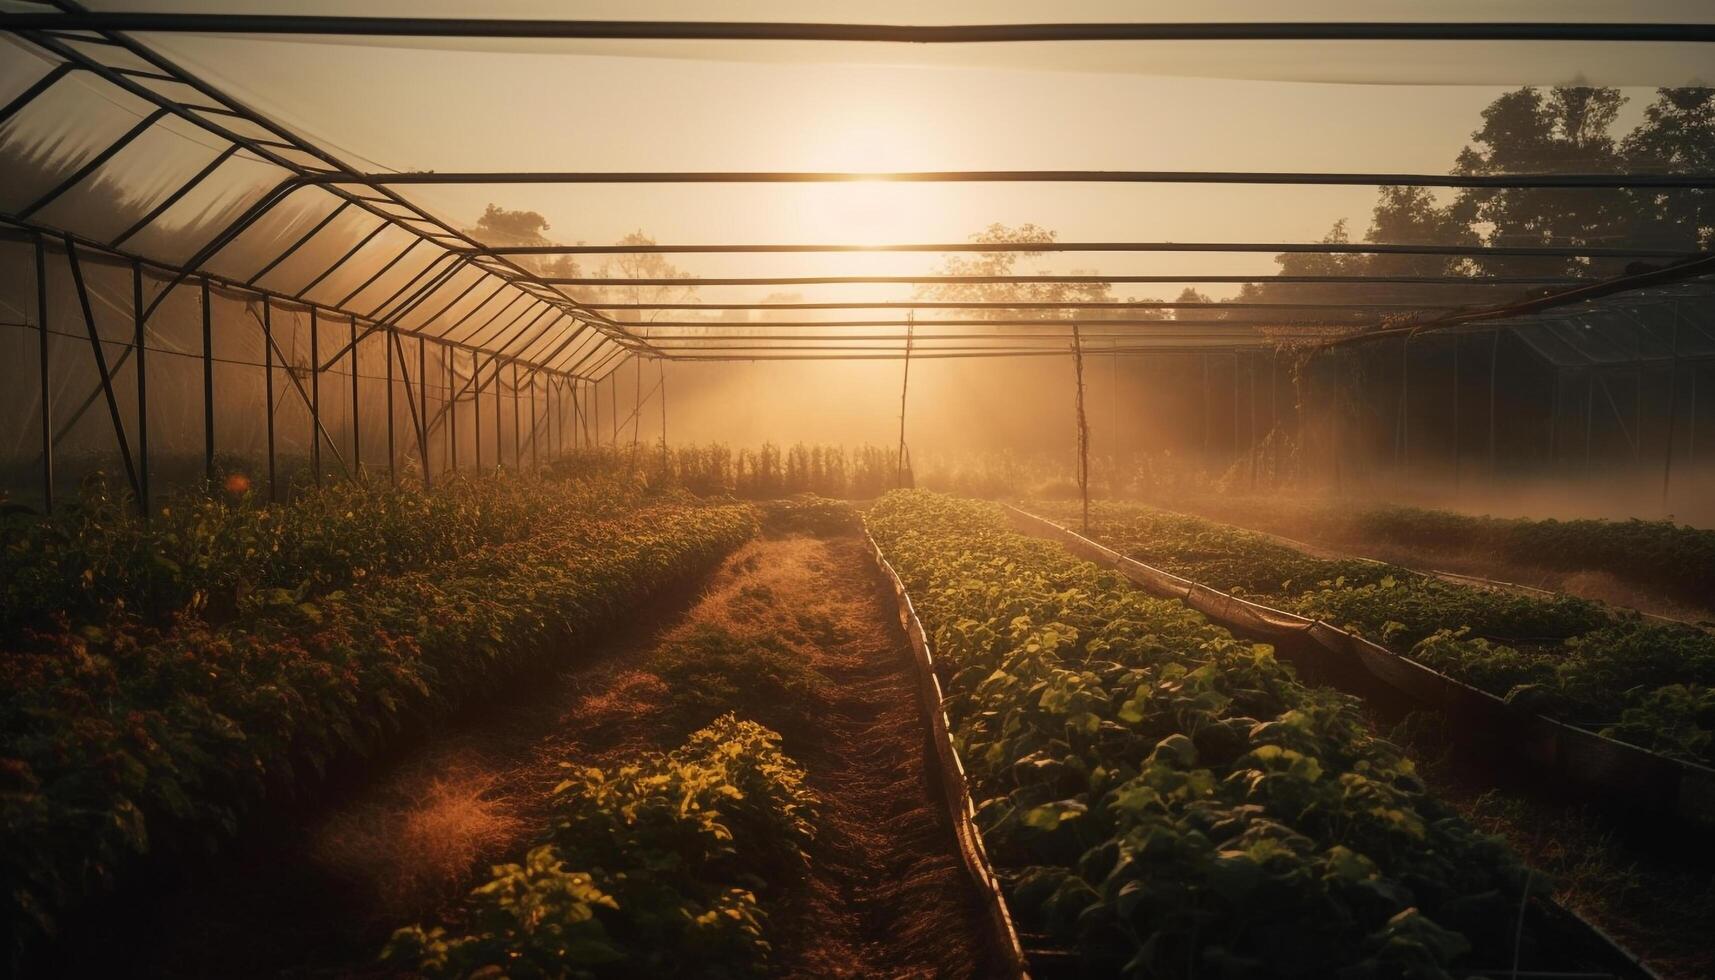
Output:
[67, 535, 988, 978]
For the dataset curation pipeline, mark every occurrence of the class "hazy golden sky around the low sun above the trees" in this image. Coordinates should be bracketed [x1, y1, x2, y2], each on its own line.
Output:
[77, 0, 1715, 298]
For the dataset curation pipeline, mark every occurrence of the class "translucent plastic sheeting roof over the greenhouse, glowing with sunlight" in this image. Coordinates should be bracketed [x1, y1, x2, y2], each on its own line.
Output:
[0, 0, 1715, 378]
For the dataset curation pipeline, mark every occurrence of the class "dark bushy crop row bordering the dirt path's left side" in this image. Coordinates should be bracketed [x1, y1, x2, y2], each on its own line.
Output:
[0, 483, 756, 954]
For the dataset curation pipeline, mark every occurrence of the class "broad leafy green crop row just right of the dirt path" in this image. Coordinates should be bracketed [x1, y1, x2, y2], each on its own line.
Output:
[868, 491, 1552, 977]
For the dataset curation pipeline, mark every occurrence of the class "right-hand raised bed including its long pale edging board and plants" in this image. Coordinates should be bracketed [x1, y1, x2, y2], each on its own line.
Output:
[1012, 505, 1715, 826]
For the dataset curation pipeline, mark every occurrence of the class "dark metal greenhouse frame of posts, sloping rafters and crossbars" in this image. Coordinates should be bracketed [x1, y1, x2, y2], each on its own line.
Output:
[0, 0, 1715, 513]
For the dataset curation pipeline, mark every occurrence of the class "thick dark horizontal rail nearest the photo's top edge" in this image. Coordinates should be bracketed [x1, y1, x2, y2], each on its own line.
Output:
[0, 12, 1715, 45]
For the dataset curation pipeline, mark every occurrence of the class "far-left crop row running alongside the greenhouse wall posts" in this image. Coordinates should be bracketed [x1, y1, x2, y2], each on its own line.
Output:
[0, 474, 655, 635]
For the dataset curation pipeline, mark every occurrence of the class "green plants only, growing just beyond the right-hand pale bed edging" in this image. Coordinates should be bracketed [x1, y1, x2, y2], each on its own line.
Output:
[1041, 503, 1715, 764]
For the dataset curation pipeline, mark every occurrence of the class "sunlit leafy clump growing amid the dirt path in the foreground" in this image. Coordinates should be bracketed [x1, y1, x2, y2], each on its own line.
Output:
[382, 714, 816, 978]
